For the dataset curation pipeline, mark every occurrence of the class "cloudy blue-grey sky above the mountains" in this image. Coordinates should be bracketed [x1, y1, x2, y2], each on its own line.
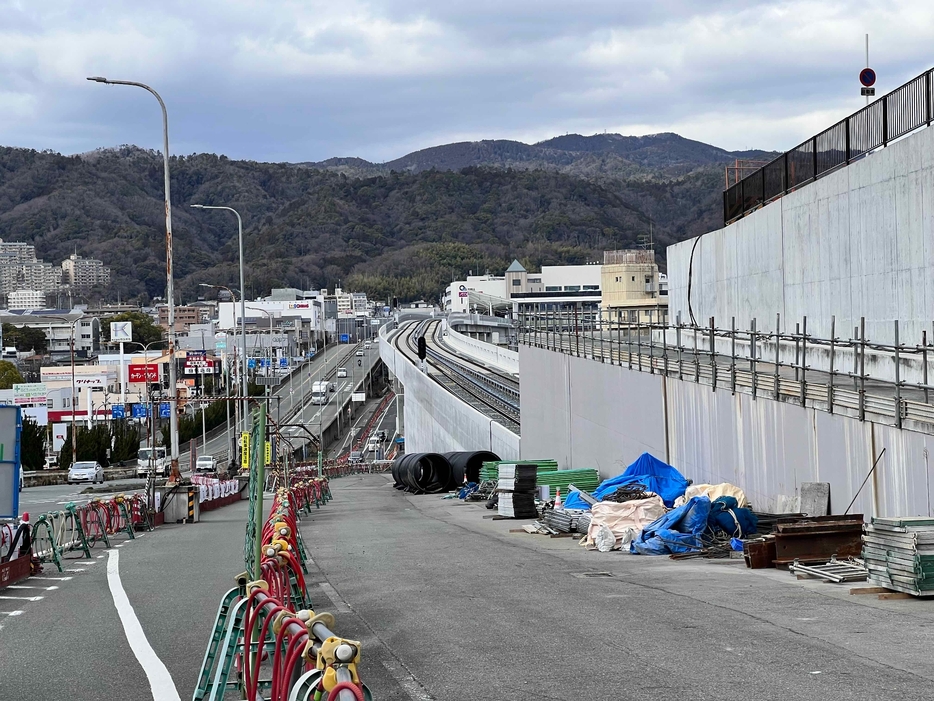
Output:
[0, 0, 934, 161]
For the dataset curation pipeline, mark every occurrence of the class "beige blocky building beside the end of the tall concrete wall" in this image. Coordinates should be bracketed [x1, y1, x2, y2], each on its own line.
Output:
[600, 249, 668, 323]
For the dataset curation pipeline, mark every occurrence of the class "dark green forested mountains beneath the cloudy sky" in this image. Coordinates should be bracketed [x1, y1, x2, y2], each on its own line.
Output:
[0, 135, 776, 302]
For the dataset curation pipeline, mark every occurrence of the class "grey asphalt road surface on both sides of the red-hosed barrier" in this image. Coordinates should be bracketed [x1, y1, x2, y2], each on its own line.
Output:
[0, 475, 934, 701]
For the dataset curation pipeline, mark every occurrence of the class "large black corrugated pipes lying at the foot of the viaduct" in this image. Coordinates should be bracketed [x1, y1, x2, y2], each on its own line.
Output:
[392, 450, 499, 494]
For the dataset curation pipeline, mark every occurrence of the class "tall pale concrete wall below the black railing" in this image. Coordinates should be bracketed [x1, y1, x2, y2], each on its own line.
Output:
[668, 123, 934, 343]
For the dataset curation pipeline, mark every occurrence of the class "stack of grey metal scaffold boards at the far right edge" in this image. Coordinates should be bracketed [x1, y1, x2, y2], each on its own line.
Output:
[863, 518, 934, 596]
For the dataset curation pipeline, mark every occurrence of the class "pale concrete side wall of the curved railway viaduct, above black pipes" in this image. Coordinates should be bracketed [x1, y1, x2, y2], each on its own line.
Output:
[379, 336, 520, 460]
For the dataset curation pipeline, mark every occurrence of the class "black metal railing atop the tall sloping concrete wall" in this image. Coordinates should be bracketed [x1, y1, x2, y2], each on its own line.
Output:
[723, 69, 934, 224]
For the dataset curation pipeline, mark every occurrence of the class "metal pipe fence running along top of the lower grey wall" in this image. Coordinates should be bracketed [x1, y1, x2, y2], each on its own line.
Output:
[519, 310, 934, 433]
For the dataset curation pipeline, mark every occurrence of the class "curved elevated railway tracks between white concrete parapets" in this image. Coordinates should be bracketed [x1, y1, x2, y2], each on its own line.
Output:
[392, 319, 520, 433]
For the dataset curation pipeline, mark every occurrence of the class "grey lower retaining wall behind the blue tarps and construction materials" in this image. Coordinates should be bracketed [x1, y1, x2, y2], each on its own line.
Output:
[519, 346, 934, 516]
